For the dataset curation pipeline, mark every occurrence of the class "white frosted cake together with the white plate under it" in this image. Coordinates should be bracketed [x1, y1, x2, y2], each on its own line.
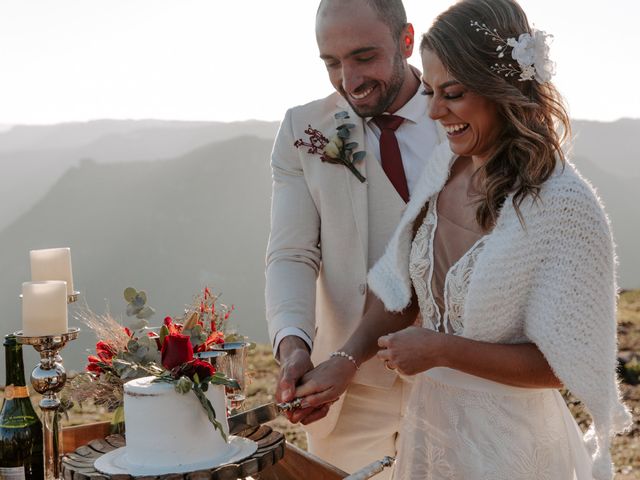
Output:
[95, 377, 257, 475]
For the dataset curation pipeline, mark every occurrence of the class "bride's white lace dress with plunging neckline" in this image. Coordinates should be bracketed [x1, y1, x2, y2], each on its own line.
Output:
[394, 196, 593, 480]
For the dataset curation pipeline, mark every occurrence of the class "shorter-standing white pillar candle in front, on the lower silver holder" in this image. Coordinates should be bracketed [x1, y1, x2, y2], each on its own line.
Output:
[22, 280, 69, 337]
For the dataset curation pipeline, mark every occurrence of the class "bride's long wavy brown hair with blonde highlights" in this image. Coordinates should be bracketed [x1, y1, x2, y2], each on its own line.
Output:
[420, 0, 571, 230]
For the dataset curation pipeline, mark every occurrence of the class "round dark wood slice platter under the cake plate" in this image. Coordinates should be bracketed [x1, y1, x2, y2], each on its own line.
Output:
[61, 425, 285, 480]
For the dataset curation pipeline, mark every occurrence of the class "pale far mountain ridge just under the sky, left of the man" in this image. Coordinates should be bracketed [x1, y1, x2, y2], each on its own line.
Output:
[0, 120, 278, 230]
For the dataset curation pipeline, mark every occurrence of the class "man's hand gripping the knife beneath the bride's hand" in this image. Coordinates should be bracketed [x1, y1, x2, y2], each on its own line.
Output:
[276, 336, 329, 424]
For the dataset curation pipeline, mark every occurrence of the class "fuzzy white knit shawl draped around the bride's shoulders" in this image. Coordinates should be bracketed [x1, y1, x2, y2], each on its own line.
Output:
[368, 144, 631, 480]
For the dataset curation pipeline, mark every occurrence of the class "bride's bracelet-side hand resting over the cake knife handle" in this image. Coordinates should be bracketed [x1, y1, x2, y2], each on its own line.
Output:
[296, 357, 356, 424]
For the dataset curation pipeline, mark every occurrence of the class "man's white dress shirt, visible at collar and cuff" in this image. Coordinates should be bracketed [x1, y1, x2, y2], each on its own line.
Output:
[273, 86, 439, 359]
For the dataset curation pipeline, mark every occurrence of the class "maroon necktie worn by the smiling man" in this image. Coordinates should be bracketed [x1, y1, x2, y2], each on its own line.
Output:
[373, 115, 409, 203]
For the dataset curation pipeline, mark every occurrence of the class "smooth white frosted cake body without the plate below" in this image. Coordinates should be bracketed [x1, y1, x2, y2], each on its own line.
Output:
[124, 377, 231, 467]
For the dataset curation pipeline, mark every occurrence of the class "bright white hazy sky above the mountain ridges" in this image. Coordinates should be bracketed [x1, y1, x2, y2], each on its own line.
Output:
[0, 0, 640, 124]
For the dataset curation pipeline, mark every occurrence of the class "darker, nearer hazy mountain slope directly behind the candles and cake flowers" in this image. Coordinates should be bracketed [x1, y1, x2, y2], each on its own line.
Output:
[0, 137, 272, 382]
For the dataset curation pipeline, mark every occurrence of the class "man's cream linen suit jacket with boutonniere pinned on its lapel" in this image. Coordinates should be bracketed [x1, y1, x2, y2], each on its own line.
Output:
[266, 93, 440, 434]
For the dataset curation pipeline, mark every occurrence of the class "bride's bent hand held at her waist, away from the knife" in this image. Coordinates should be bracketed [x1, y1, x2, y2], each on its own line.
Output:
[377, 326, 447, 375]
